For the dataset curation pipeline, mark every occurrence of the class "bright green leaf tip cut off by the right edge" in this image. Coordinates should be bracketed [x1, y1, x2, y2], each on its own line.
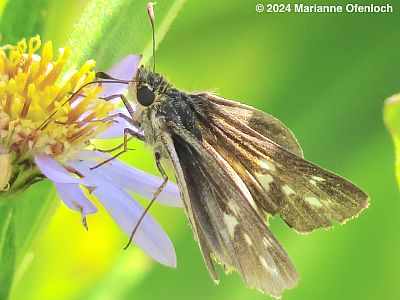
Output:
[383, 94, 400, 184]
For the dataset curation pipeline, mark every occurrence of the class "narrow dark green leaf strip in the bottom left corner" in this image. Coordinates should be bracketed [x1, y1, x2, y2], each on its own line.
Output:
[0, 204, 16, 300]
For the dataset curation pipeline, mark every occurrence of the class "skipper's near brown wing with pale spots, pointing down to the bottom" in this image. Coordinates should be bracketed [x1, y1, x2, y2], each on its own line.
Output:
[159, 129, 298, 297]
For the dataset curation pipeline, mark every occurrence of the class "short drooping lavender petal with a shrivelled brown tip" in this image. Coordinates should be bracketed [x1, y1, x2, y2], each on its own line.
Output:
[54, 182, 97, 228]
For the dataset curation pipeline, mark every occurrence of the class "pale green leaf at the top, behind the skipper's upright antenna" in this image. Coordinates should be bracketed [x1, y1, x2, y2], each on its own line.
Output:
[63, 0, 185, 70]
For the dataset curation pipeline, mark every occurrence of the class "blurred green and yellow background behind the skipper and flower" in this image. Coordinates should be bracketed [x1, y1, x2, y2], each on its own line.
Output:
[0, 0, 400, 300]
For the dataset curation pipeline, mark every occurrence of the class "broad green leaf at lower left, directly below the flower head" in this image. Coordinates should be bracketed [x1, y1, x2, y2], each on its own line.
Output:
[0, 180, 59, 300]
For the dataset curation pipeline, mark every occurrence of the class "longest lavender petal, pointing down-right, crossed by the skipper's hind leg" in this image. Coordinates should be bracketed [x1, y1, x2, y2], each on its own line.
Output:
[72, 161, 176, 267]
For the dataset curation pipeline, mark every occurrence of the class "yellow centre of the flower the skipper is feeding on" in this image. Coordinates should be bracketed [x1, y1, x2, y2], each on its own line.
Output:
[0, 36, 115, 160]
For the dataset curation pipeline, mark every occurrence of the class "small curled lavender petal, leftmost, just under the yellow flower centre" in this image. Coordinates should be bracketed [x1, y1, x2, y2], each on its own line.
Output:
[35, 154, 94, 186]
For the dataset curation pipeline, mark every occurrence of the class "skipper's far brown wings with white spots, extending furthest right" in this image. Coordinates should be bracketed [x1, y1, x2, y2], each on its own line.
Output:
[203, 94, 368, 232]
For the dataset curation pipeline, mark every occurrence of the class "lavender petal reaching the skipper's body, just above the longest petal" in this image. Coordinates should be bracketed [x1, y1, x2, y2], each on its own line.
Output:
[70, 151, 183, 207]
